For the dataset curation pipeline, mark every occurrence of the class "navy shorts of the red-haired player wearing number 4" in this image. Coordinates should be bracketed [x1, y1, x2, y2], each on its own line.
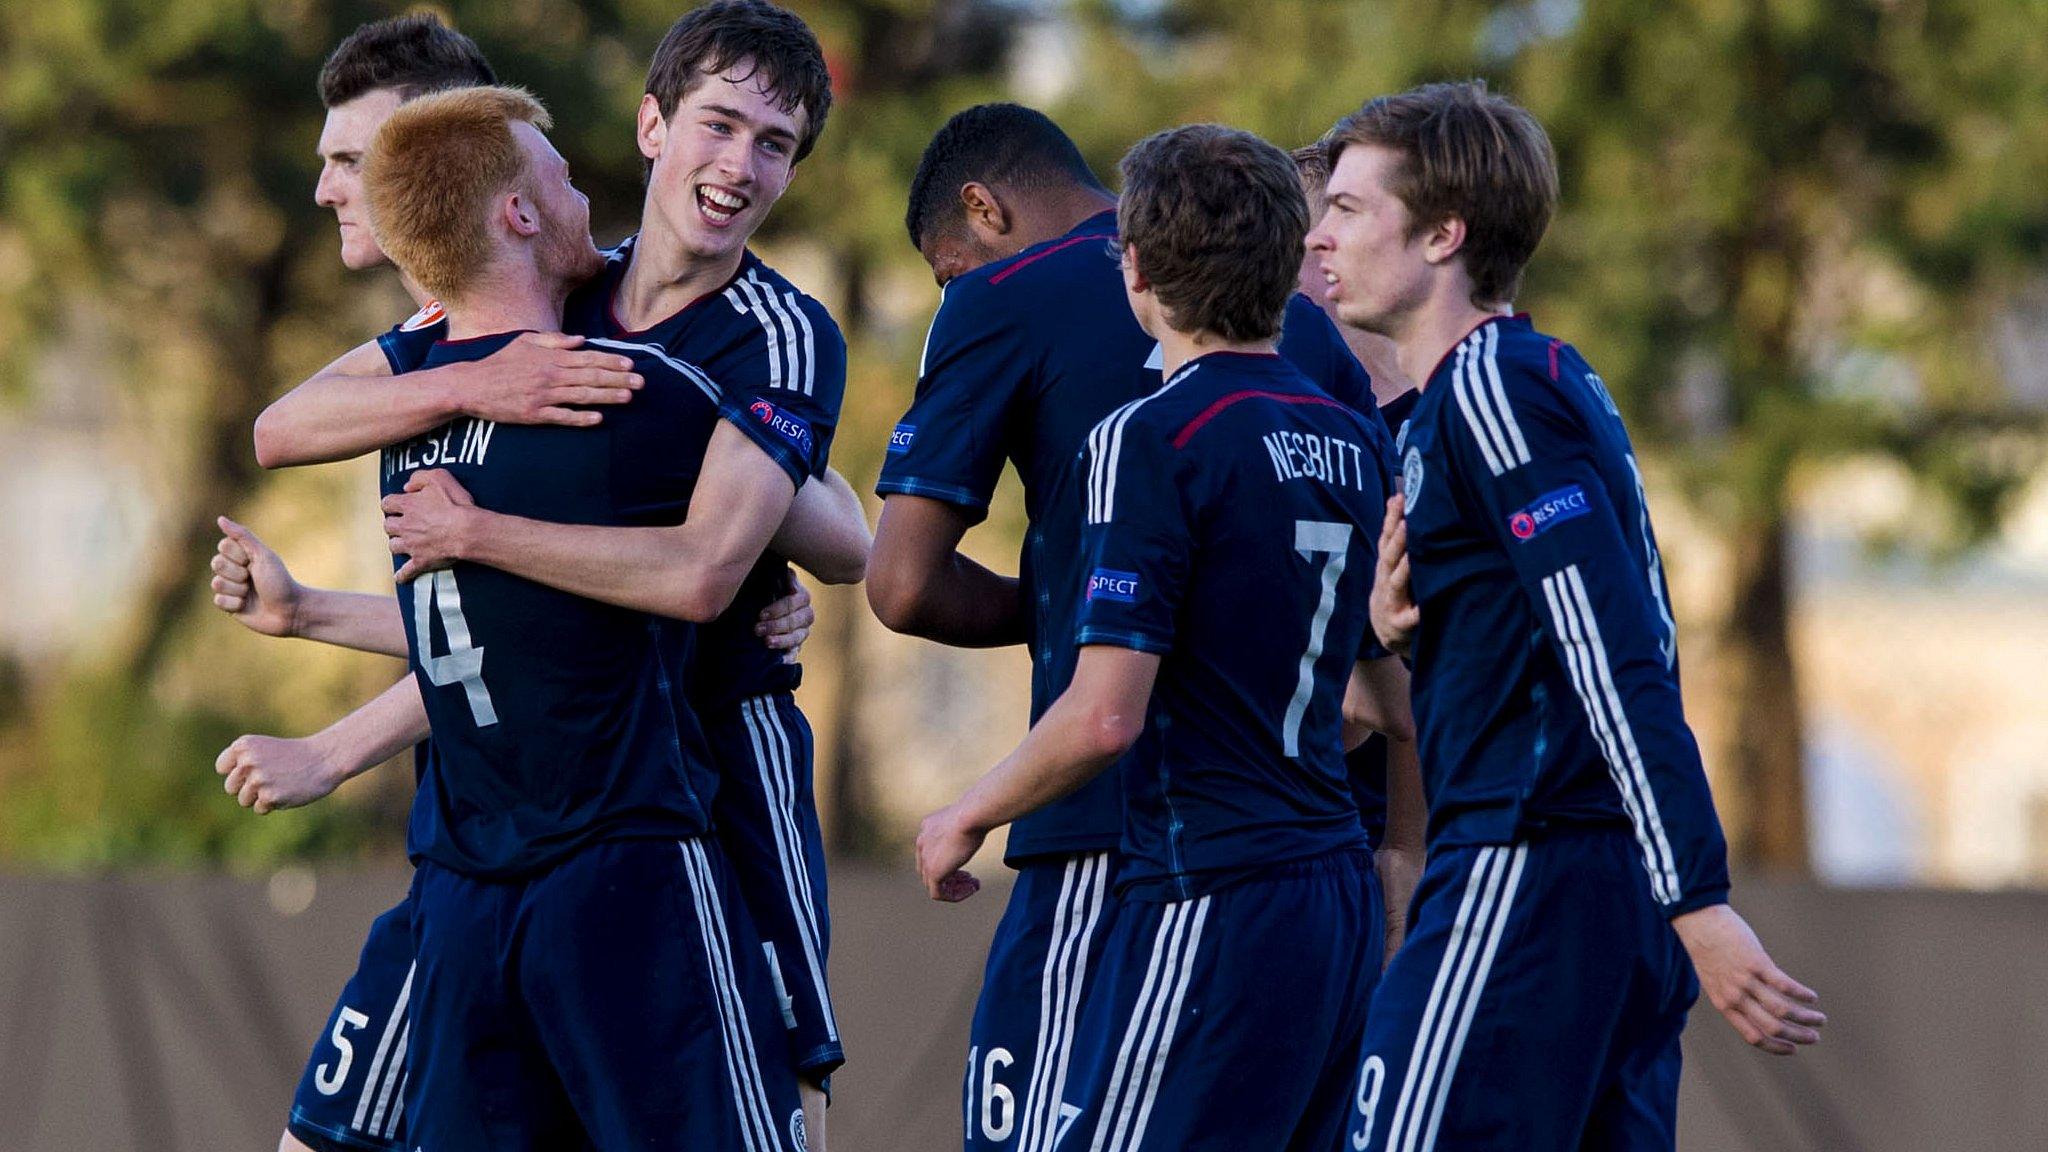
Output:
[406, 838, 805, 1152]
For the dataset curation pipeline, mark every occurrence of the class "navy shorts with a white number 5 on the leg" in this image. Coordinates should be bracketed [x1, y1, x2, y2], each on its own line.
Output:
[285, 894, 412, 1152]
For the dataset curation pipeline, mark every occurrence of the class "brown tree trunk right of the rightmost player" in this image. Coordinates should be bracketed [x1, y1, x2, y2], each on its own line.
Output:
[1720, 510, 1812, 873]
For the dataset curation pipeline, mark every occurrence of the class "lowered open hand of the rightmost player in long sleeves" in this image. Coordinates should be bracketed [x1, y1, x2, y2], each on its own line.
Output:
[1671, 904, 1827, 1056]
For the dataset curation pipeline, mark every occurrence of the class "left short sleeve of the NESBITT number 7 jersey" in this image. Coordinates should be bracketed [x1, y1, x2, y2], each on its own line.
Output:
[1075, 414, 1194, 654]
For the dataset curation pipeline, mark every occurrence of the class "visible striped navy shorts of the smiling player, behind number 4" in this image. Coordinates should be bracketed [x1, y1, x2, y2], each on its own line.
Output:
[702, 693, 846, 1082]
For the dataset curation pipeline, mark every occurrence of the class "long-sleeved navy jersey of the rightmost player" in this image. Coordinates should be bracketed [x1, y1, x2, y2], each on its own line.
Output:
[1401, 318, 1729, 914]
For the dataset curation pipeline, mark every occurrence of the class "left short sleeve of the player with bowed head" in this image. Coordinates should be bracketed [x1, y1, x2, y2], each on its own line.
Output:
[874, 283, 1034, 519]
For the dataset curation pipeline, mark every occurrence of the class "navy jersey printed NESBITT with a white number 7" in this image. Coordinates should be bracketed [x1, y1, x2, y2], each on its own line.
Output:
[1075, 353, 1393, 900]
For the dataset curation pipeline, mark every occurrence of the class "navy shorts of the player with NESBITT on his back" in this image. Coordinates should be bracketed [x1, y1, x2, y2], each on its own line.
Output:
[1047, 851, 1384, 1152]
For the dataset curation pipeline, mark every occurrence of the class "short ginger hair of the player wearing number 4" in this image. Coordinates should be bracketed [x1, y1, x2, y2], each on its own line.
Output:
[362, 88, 553, 299]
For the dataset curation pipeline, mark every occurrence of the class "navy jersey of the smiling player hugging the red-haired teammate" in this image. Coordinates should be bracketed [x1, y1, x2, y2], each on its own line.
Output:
[563, 238, 846, 709]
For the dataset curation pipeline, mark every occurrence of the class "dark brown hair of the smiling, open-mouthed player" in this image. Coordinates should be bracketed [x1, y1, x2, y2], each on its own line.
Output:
[647, 0, 831, 164]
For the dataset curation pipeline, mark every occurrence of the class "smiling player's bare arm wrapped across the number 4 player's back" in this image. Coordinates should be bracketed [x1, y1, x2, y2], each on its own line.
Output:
[385, 420, 803, 623]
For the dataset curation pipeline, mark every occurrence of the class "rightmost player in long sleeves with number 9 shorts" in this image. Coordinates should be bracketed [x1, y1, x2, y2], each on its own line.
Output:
[1309, 82, 1825, 1152]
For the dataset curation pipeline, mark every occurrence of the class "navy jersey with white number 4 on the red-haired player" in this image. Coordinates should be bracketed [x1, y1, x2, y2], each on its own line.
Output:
[381, 334, 756, 879]
